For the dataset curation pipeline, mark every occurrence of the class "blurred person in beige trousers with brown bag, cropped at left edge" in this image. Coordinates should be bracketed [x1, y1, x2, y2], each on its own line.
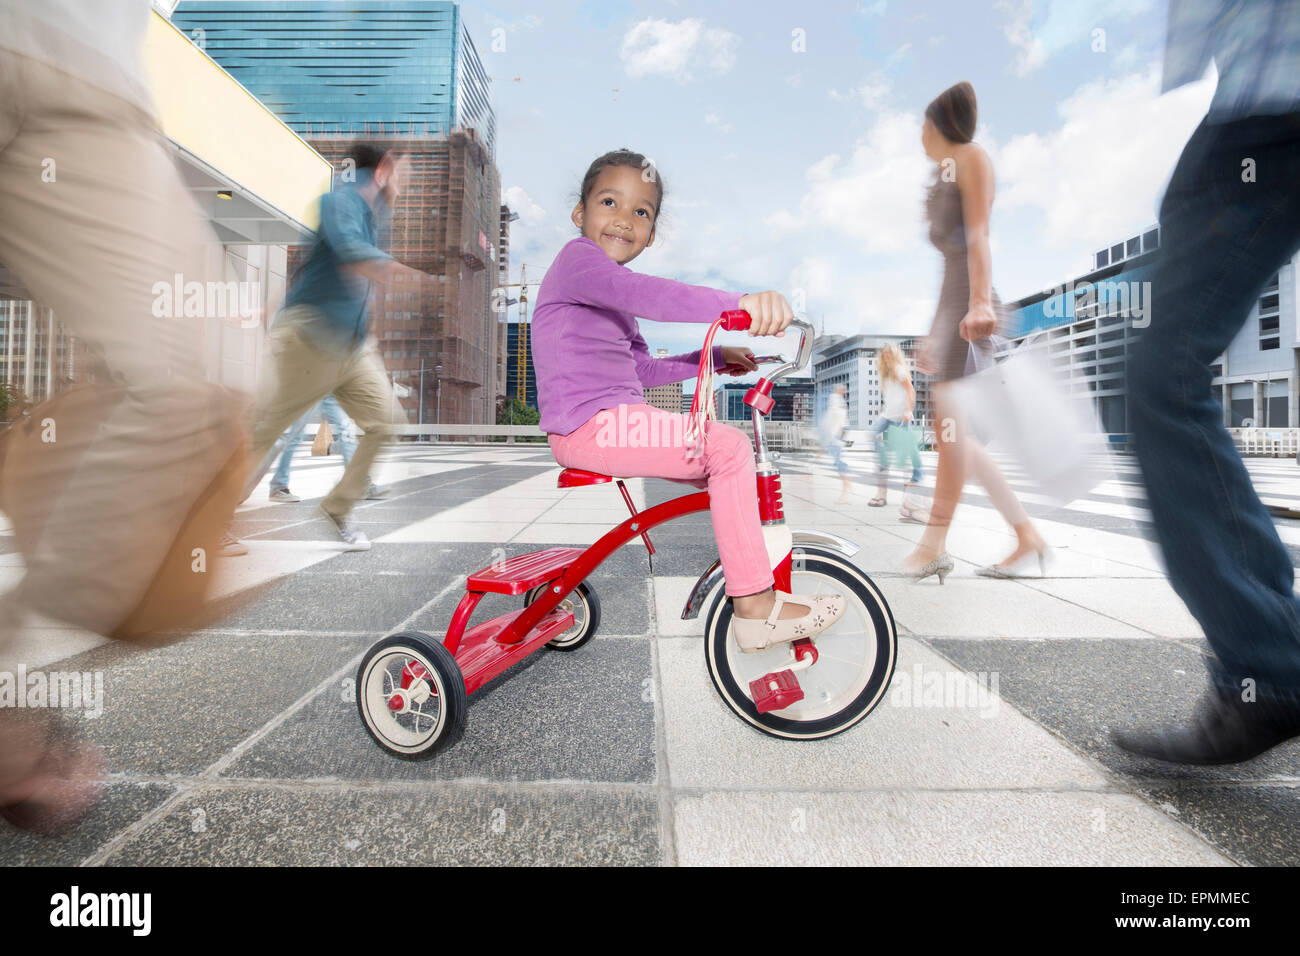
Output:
[0, 0, 242, 832]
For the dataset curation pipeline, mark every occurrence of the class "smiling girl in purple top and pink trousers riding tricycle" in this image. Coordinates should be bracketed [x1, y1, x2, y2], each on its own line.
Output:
[532, 150, 846, 652]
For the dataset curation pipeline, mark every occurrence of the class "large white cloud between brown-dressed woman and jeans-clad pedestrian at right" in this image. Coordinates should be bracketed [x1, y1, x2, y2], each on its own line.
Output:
[995, 66, 1214, 248]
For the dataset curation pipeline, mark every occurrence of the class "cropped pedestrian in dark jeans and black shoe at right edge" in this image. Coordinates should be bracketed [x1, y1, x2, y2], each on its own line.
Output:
[1115, 0, 1300, 763]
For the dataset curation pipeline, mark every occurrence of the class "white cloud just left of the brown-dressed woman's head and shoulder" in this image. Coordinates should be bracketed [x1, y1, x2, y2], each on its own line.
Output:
[764, 112, 930, 254]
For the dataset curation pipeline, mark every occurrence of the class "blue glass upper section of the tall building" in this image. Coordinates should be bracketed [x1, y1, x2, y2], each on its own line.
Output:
[172, 0, 497, 157]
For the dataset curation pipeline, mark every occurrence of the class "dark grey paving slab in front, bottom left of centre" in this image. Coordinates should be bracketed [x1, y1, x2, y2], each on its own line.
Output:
[98, 787, 660, 868]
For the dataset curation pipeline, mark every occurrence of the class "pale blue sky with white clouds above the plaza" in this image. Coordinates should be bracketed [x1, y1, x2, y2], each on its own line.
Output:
[462, 0, 1213, 352]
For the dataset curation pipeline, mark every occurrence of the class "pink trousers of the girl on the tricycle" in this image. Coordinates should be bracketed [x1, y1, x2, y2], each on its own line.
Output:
[550, 405, 772, 597]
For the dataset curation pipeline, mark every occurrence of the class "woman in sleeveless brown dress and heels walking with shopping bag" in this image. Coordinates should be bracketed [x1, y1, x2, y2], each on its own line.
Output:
[904, 83, 1047, 584]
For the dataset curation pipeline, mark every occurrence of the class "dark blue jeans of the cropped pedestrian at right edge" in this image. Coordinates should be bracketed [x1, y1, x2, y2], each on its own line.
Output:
[1128, 113, 1300, 709]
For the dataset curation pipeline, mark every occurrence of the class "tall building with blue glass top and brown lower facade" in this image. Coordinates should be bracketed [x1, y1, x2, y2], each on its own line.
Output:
[173, 0, 508, 423]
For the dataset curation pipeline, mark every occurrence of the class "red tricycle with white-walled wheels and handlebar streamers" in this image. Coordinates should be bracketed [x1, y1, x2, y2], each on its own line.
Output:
[356, 311, 898, 760]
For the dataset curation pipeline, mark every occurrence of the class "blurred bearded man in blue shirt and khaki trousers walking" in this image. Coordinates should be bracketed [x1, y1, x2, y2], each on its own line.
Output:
[246, 146, 428, 551]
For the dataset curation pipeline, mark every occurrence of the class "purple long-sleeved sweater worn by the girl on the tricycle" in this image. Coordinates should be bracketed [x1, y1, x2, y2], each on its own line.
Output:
[532, 238, 741, 434]
